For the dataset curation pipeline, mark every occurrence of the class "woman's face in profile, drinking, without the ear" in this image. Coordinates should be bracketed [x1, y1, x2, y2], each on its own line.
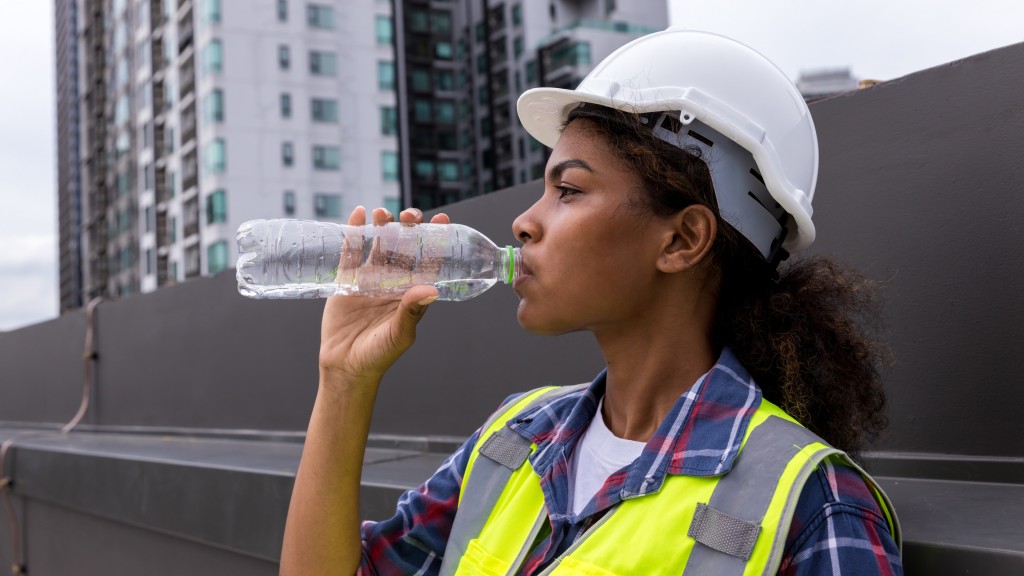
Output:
[512, 120, 664, 334]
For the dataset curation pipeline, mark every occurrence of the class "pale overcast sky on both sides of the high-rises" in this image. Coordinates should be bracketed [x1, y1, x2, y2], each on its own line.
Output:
[0, 0, 1024, 330]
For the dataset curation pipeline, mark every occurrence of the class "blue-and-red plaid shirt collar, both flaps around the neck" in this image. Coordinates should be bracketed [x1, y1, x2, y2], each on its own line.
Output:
[508, 348, 761, 498]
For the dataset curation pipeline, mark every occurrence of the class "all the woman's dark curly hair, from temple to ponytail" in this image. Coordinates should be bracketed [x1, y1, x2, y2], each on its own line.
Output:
[565, 105, 889, 457]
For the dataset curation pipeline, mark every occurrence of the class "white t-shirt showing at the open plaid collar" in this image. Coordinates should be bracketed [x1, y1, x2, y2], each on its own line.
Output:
[571, 397, 646, 515]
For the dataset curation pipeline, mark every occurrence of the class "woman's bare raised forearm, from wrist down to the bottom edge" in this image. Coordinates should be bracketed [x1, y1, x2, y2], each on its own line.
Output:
[281, 370, 379, 575]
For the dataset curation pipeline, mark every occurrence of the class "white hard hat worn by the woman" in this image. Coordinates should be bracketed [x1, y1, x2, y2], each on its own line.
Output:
[517, 28, 818, 260]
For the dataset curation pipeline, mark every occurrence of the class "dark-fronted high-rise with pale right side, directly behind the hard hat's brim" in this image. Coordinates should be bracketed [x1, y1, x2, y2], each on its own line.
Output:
[395, 0, 669, 208]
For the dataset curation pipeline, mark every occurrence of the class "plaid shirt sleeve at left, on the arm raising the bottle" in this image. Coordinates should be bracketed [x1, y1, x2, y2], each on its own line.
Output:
[356, 395, 517, 576]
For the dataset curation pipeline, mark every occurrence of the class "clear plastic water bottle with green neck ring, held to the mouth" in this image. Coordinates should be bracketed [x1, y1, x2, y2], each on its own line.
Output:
[236, 219, 522, 300]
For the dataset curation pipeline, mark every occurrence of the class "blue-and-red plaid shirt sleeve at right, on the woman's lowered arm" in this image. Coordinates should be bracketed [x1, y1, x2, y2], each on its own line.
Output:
[778, 457, 903, 576]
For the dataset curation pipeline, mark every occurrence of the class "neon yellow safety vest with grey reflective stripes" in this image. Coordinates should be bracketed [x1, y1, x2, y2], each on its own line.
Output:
[440, 386, 901, 576]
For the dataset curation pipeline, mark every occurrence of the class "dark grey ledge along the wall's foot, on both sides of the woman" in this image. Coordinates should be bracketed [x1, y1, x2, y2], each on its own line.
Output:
[0, 423, 1024, 574]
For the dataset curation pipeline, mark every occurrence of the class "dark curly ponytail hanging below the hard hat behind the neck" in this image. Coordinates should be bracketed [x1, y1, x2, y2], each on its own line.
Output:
[716, 239, 889, 458]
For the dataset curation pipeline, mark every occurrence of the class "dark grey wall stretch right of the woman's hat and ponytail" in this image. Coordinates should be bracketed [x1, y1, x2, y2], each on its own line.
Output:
[811, 45, 1024, 456]
